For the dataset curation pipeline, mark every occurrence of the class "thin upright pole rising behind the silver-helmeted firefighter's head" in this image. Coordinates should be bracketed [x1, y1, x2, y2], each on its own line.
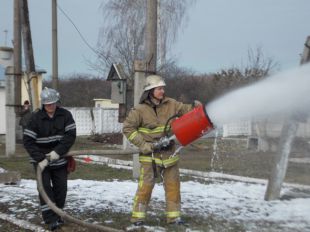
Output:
[52, 0, 58, 89]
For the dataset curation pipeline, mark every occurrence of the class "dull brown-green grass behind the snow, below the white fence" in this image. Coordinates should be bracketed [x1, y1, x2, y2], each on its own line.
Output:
[0, 136, 310, 185]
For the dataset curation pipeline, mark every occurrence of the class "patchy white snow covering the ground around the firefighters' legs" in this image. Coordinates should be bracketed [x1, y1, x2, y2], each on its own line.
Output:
[0, 179, 310, 231]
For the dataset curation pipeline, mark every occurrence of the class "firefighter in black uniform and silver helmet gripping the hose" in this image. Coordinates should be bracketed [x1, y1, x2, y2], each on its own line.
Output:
[23, 88, 76, 230]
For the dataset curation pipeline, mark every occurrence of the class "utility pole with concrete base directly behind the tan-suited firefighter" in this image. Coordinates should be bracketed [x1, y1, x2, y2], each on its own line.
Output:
[132, 0, 158, 178]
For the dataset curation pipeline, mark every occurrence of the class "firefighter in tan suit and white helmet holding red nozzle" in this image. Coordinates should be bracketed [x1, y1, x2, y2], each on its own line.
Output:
[123, 75, 201, 226]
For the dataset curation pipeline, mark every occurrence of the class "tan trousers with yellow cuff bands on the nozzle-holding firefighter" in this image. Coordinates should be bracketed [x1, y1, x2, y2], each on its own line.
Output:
[131, 162, 181, 223]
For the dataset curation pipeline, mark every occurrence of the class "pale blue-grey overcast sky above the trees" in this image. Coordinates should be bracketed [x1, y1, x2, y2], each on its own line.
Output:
[0, 0, 310, 75]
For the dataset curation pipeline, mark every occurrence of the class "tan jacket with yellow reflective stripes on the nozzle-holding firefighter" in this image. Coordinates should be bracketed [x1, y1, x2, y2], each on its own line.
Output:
[123, 97, 193, 167]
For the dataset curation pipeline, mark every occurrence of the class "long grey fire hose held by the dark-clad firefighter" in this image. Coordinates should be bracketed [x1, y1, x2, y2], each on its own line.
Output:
[36, 150, 138, 232]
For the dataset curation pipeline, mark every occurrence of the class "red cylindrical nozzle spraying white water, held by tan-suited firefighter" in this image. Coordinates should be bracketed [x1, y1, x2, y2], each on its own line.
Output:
[171, 105, 214, 146]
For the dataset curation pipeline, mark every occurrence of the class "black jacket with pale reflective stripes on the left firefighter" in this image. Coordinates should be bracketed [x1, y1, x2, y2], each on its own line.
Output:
[23, 107, 76, 167]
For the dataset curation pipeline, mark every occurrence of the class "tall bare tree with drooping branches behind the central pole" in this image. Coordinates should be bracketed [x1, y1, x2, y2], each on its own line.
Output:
[92, 0, 194, 79]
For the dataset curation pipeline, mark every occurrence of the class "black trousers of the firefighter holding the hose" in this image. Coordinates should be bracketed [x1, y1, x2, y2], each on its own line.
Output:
[35, 165, 68, 224]
